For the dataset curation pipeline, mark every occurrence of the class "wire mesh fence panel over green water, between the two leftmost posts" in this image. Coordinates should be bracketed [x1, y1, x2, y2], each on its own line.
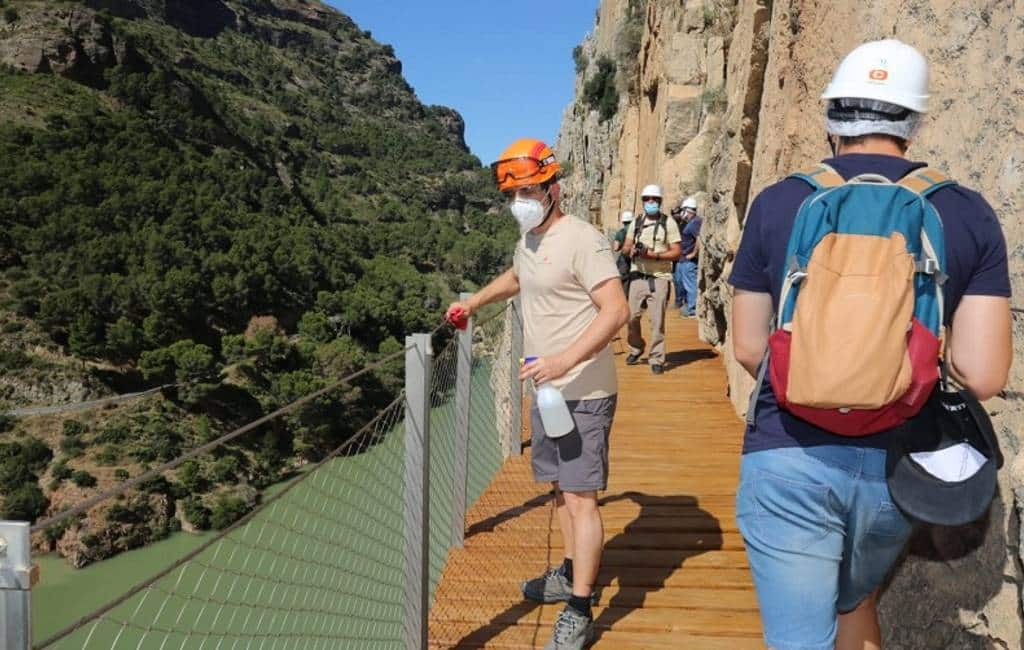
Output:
[36, 396, 406, 650]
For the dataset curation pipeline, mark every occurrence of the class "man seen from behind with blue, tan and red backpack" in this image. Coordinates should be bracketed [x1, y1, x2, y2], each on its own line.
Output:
[729, 40, 1012, 650]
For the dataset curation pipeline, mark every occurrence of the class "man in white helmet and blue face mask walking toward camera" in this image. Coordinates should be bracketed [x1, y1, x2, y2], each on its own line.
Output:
[623, 185, 682, 375]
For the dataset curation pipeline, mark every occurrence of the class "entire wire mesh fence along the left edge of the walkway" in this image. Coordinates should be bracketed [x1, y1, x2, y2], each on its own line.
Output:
[6, 307, 545, 650]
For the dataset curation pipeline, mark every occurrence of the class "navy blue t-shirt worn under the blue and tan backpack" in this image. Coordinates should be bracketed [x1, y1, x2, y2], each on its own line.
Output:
[729, 154, 1010, 453]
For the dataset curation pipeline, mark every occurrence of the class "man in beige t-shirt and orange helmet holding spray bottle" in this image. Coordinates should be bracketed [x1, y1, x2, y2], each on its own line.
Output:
[449, 139, 629, 650]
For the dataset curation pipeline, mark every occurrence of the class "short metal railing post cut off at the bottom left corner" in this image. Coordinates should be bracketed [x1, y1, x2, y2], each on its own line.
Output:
[0, 521, 33, 650]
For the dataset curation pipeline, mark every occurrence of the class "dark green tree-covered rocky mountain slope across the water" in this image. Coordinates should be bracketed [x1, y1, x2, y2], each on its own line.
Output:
[0, 0, 516, 565]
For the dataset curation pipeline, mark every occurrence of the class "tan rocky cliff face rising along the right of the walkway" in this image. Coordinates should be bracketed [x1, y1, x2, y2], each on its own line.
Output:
[558, 0, 1024, 648]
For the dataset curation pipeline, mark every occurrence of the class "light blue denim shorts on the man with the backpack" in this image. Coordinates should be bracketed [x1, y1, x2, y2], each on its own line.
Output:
[736, 445, 911, 650]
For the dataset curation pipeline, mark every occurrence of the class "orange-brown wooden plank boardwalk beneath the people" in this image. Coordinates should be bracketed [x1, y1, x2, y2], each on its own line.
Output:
[430, 311, 764, 650]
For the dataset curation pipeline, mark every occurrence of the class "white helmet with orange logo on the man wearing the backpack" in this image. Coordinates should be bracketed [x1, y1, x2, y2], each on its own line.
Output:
[821, 39, 929, 113]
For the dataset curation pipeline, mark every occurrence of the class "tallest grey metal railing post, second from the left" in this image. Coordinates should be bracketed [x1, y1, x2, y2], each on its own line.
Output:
[402, 334, 434, 650]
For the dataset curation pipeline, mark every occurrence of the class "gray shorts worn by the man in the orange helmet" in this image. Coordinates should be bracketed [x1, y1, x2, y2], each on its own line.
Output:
[529, 395, 618, 492]
